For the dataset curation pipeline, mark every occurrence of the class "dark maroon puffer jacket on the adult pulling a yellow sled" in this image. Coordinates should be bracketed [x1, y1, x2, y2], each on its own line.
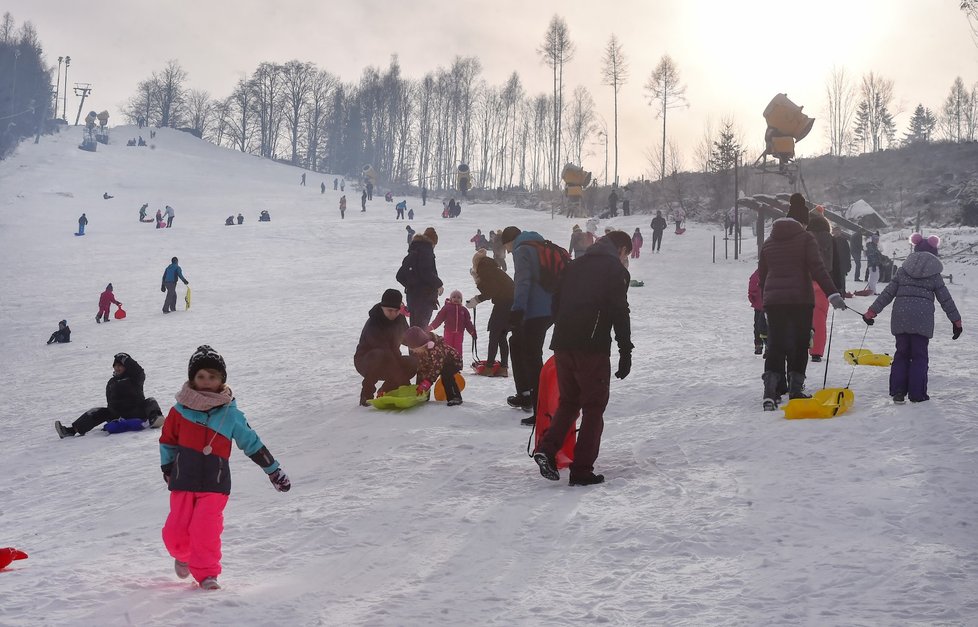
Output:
[757, 218, 839, 308]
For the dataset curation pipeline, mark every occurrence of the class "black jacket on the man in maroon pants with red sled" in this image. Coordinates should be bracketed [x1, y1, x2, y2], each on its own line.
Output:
[550, 238, 632, 354]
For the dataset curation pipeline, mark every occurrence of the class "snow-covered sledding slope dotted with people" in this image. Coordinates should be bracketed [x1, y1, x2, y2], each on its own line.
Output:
[0, 127, 978, 625]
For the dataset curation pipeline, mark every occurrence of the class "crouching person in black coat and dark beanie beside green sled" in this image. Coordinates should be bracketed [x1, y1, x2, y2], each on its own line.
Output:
[353, 289, 418, 406]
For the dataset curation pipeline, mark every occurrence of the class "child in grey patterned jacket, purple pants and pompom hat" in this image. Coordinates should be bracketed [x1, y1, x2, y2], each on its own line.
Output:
[863, 233, 962, 403]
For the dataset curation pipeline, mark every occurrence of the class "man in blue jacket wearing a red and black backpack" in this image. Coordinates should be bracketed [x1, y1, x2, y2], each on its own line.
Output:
[500, 226, 570, 426]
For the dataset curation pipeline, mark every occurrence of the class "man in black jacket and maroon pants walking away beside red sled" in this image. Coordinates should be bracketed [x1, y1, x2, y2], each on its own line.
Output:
[533, 231, 633, 485]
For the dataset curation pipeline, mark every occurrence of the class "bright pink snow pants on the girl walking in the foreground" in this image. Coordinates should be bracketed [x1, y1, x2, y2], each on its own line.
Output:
[163, 491, 228, 582]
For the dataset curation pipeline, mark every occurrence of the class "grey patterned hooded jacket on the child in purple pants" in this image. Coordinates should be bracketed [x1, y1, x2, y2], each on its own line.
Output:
[869, 252, 961, 337]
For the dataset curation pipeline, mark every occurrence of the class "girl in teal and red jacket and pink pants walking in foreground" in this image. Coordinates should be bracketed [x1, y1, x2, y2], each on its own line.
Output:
[160, 344, 292, 590]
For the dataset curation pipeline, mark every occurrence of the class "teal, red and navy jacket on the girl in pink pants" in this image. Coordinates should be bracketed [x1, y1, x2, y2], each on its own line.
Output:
[160, 384, 279, 494]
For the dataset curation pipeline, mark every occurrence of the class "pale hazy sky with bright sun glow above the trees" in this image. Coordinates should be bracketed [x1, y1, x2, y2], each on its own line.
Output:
[7, 0, 978, 179]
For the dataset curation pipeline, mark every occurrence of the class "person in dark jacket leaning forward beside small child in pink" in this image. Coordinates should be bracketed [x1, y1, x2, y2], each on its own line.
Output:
[465, 249, 515, 377]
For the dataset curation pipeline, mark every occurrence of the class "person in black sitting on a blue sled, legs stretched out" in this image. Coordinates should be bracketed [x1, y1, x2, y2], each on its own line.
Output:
[54, 353, 163, 438]
